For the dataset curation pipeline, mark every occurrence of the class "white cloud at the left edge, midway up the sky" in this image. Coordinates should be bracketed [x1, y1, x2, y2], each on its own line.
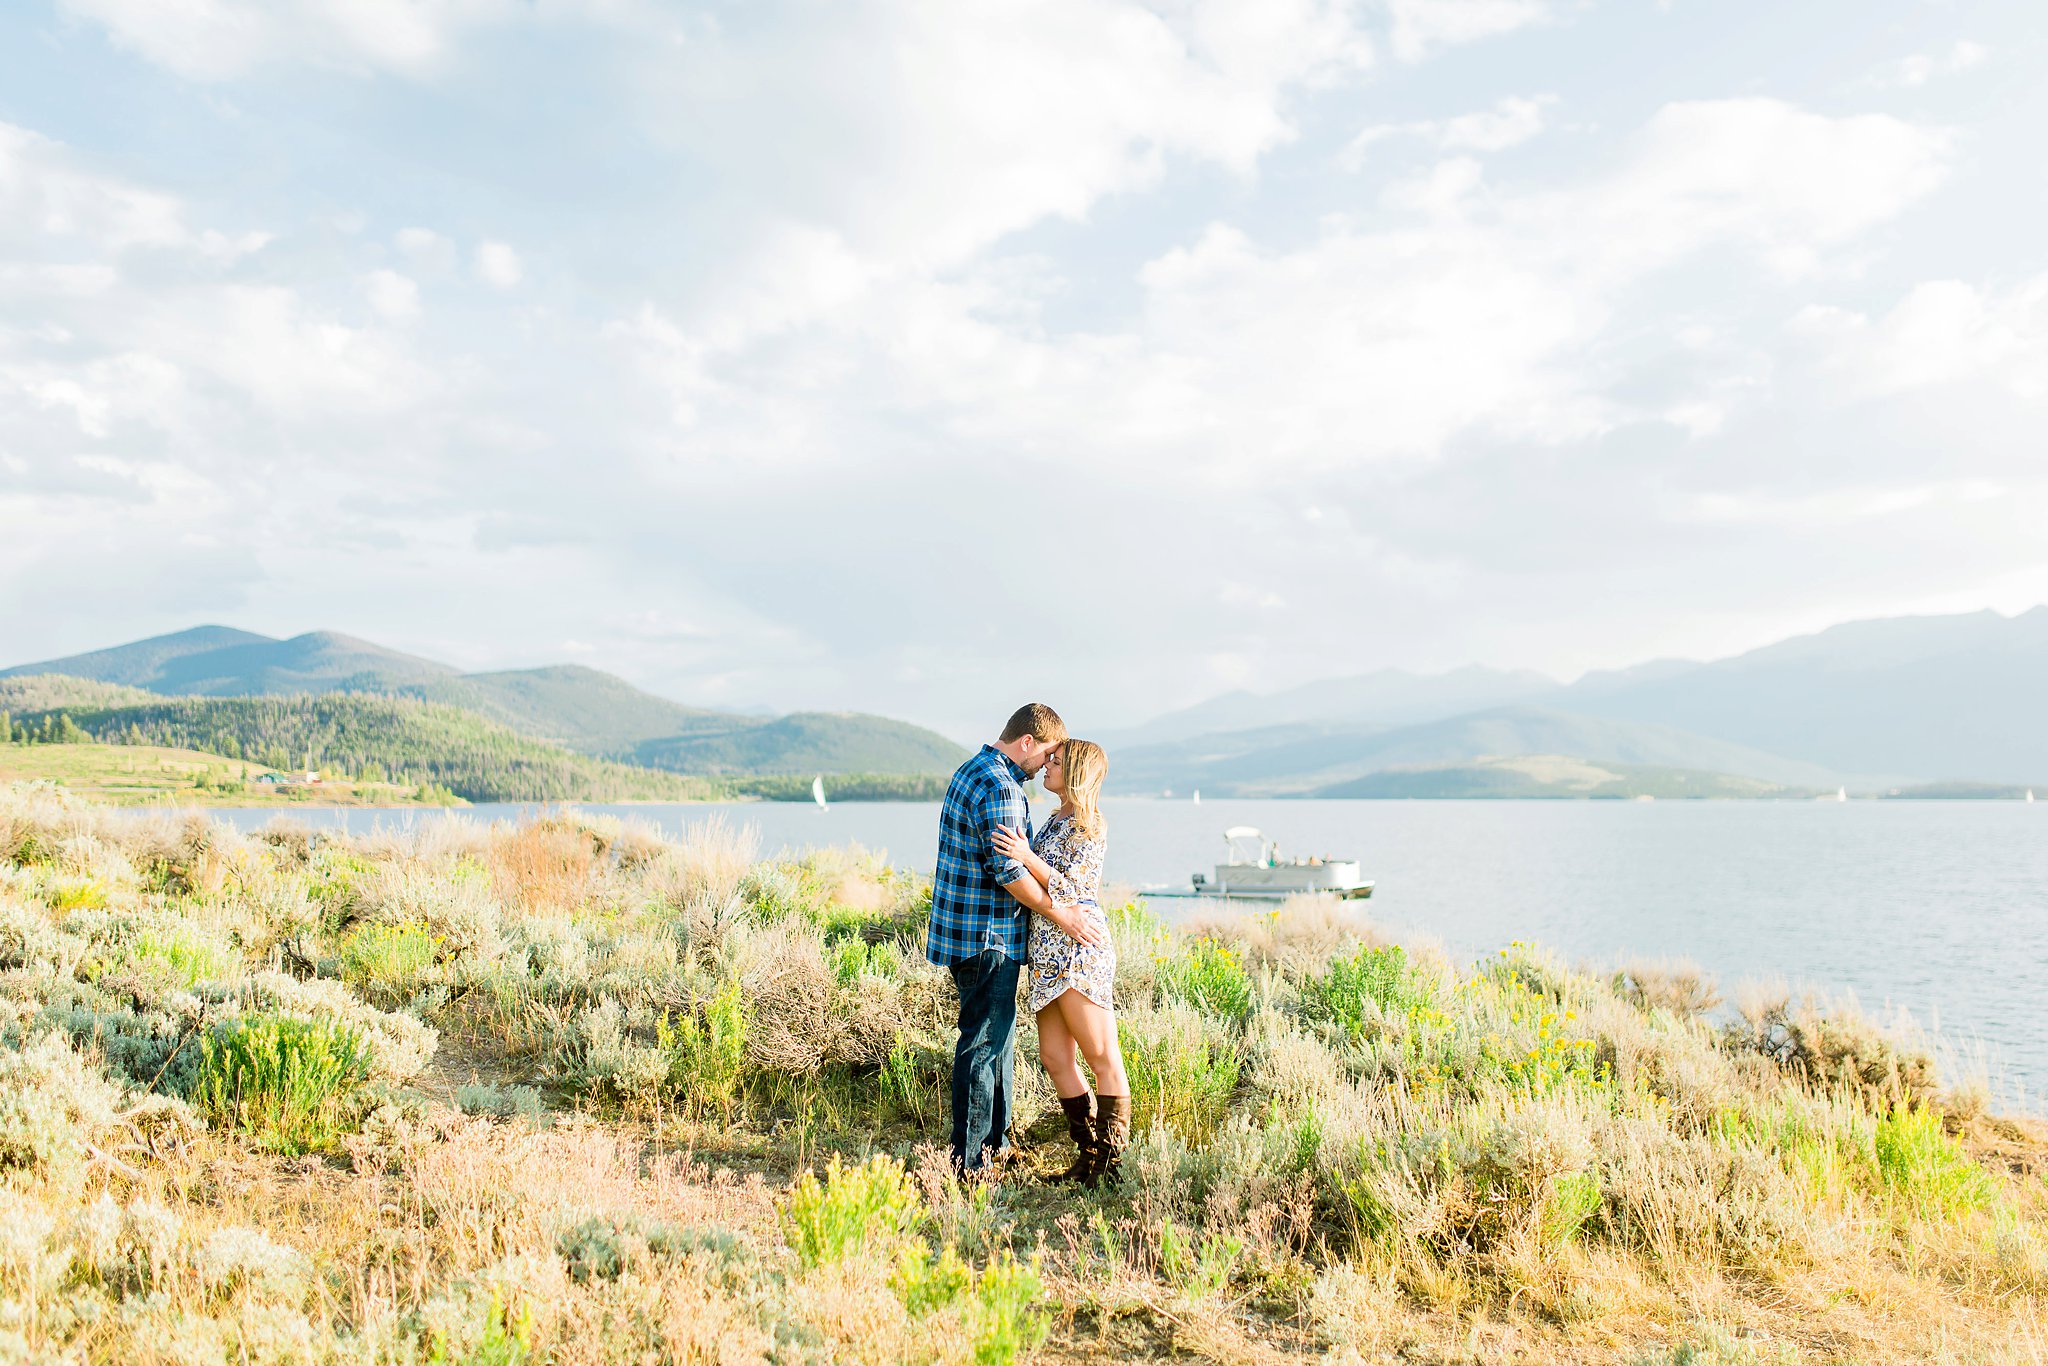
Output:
[0, 125, 432, 461]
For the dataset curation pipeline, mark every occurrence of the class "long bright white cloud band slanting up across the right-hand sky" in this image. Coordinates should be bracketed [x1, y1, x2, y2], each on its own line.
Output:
[614, 100, 1946, 483]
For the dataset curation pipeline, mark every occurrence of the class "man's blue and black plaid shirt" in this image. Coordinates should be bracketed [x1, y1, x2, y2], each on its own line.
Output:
[924, 745, 1030, 967]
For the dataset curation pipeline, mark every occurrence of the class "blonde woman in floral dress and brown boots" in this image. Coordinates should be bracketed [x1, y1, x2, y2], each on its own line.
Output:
[995, 739, 1130, 1186]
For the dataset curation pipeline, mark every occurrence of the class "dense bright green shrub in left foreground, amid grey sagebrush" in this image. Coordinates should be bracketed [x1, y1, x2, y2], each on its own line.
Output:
[197, 1016, 371, 1153]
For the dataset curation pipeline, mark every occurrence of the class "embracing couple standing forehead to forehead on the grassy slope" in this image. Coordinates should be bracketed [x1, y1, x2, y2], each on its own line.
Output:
[926, 702, 1130, 1186]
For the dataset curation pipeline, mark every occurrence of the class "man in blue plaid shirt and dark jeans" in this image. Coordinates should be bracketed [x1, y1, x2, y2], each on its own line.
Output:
[924, 702, 1067, 1171]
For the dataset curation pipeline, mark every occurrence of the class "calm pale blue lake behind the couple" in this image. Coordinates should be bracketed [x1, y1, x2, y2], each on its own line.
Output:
[217, 799, 2048, 1108]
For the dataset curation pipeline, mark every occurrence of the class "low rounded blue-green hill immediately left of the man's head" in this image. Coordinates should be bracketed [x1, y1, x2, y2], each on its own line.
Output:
[633, 711, 967, 774]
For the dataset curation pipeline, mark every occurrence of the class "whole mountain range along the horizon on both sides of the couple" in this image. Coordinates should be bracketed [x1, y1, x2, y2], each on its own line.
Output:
[0, 606, 2048, 797]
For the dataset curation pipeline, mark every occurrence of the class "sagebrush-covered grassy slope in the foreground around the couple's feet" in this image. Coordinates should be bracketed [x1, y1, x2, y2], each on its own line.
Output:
[0, 788, 2048, 1366]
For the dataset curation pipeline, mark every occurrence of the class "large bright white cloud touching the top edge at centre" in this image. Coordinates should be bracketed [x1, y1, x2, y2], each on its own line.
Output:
[641, 0, 1370, 348]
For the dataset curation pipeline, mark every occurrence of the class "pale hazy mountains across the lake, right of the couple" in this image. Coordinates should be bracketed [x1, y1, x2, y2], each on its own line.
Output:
[1106, 606, 2048, 795]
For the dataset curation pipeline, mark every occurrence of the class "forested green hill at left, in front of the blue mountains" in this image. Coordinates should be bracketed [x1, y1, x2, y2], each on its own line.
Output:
[16, 692, 719, 801]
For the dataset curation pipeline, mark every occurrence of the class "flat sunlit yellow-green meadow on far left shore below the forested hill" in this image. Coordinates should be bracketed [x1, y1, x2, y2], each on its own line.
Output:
[0, 743, 444, 807]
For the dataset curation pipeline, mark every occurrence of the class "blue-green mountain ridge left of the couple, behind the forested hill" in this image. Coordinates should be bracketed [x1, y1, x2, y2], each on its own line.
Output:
[0, 627, 967, 774]
